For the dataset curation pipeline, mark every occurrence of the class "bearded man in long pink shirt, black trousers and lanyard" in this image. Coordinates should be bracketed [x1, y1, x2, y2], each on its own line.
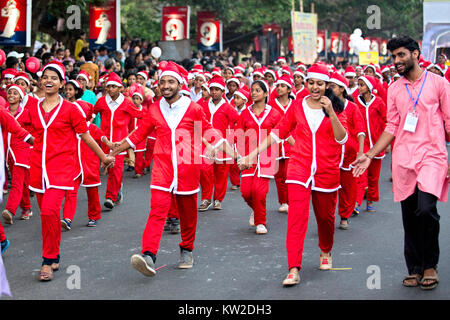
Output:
[353, 37, 450, 290]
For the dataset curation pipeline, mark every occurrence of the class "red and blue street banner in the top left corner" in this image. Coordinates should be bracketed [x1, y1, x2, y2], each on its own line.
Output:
[0, 0, 31, 47]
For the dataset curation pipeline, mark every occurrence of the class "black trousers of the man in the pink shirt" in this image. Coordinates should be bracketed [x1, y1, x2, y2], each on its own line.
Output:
[401, 187, 440, 275]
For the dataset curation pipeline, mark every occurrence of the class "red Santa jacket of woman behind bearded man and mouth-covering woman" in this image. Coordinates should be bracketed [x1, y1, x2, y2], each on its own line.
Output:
[235, 104, 281, 178]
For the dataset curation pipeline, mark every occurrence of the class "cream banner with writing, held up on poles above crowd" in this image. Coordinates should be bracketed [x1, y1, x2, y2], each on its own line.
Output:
[291, 11, 317, 64]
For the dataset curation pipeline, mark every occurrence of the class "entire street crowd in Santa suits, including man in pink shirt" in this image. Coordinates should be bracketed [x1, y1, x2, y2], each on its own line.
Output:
[0, 36, 450, 289]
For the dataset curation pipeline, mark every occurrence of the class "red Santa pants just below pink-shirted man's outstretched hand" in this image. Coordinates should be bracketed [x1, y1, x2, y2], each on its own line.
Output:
[356, 159, 381, 205]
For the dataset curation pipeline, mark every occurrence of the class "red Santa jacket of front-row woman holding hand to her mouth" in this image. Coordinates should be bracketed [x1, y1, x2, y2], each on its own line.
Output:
[271, 98, 347, 192]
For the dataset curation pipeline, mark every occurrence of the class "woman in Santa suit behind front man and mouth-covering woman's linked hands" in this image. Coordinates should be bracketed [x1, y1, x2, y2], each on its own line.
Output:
[235, 80, 281, 234]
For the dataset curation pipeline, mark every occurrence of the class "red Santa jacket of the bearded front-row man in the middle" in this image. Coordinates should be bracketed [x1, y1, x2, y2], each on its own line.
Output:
[126, 97, 224, 194]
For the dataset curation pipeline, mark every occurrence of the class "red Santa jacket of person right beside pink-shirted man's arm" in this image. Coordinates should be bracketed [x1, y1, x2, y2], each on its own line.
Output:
[356, 95, 387, 159]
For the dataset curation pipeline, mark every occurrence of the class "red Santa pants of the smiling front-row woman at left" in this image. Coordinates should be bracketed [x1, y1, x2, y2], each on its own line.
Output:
[36, 188, 66, 260]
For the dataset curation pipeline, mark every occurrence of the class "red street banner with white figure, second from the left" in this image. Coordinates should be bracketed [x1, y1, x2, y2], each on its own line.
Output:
[89, 0, 121, 51]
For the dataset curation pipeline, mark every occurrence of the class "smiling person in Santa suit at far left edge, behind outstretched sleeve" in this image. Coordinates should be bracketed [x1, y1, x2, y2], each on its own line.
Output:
[2, 84, 33, 224]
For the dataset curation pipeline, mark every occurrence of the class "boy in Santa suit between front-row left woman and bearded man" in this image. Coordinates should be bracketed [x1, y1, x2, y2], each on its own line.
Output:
[94, 72, 142, 209]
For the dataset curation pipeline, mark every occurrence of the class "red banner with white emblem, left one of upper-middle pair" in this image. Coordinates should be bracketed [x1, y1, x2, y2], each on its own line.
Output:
[161, 6, 191, 41]
